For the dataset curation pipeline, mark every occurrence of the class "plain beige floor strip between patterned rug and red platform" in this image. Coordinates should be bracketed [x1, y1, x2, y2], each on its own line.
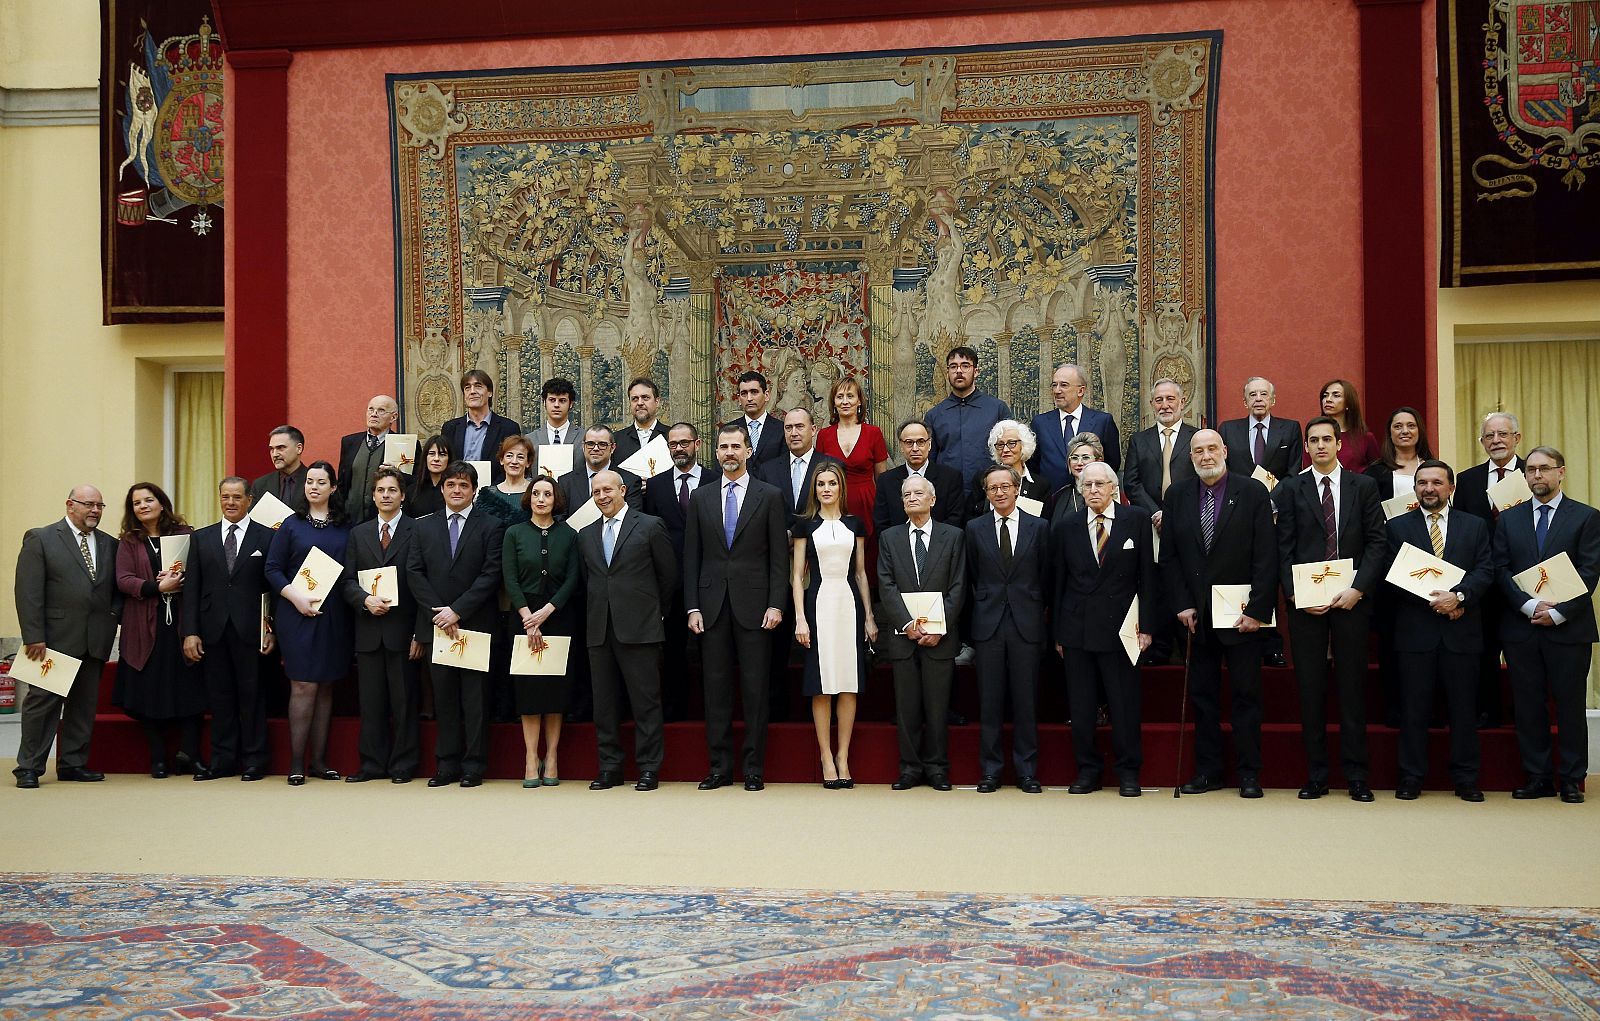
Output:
[0, 776, 1600, 906]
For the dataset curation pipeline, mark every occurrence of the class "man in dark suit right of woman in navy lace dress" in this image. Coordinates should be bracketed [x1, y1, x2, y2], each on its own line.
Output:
[339, 467, 422, 784]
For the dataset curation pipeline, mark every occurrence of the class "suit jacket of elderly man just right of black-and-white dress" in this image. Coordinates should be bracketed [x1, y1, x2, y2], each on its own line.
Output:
[878, 524, 966, 659]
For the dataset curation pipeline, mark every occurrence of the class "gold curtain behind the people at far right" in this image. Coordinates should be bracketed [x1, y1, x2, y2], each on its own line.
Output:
[1456, 339, 1600, 709]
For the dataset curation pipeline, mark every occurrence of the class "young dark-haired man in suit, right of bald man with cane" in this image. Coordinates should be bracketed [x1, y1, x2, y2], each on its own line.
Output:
[1275, 416, 1389, 802]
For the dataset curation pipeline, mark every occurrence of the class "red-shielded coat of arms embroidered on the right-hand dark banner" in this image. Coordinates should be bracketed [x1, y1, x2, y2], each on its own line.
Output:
[1472, 0, 1600, 202]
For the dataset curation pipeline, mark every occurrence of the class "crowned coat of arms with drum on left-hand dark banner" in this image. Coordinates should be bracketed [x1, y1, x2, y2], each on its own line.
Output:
[117, 18, 224, 235]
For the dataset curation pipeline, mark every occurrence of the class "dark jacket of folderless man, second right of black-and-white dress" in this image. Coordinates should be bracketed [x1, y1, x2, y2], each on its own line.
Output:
[966, 511, 1051, 642]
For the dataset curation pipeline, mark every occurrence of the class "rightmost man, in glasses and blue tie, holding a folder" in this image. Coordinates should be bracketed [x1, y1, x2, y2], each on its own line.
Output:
[1494, 446, 1600, 805]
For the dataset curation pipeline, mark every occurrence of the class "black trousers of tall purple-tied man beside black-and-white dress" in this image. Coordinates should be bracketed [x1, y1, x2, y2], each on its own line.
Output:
[701, 597, 782, 776]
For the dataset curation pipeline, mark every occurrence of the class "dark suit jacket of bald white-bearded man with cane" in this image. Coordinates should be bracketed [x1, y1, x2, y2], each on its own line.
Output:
[1162, 472, 1278, 645]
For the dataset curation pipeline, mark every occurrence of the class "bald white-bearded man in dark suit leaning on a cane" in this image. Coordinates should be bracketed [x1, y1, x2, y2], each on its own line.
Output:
[1162, 429, 1278, 799]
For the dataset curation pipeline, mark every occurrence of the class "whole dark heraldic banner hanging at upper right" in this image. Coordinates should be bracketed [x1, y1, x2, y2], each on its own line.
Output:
[1438, 0, 1600, 286]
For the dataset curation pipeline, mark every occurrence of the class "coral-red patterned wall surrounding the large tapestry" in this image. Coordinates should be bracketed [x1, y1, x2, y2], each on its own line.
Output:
[275, 0, 1363, 456]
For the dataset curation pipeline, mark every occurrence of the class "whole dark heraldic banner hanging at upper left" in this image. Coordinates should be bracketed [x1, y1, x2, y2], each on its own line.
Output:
[101, 0, 224, 325]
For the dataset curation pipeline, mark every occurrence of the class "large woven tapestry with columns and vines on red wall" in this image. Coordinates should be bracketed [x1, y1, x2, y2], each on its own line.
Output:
[389, 34, 1221, 444]
